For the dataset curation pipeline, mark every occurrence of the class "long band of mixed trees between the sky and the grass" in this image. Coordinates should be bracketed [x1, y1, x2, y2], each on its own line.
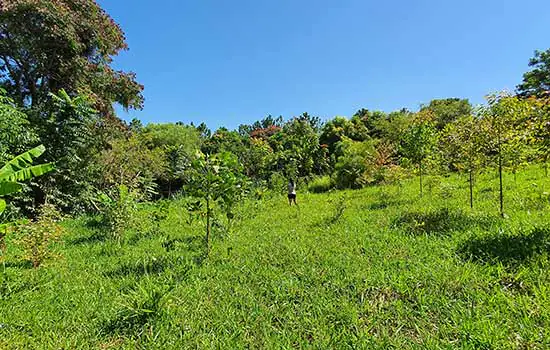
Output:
[0, 0, 550, 220]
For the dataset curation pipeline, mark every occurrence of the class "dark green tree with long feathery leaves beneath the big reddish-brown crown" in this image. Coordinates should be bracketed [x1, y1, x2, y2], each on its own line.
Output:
[33, 90, 105, 211]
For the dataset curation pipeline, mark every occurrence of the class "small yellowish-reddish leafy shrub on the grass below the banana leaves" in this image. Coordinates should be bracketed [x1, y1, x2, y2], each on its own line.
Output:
[15, 204, 63, 268]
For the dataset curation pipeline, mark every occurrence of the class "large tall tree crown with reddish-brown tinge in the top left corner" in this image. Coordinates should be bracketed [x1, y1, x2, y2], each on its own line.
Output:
[0, 0, 143, 114]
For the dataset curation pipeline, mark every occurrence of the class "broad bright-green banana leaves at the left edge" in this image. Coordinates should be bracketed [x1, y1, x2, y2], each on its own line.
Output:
[0, 145, 54, 217]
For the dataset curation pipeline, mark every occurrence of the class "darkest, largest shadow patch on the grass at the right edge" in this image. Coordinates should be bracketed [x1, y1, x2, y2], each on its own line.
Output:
[458, 228, 550, 266]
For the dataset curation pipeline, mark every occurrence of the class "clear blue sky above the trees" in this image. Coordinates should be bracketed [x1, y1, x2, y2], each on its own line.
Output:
[98, 0, 550, 129]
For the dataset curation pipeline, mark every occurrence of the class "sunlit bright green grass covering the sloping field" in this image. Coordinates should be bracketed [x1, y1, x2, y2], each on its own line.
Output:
[0, 167, 550, 349]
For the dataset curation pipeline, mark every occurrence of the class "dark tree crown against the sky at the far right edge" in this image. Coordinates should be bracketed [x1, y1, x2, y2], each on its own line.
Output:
[517, 49, 550, 97]
